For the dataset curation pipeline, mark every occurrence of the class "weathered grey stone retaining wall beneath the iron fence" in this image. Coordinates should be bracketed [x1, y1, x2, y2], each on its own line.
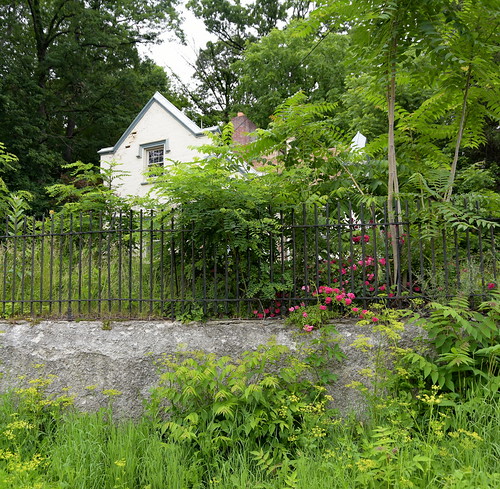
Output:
[0, 321, 421, 417]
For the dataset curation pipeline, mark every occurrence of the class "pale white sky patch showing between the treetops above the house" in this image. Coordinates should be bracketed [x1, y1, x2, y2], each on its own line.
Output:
[139, 9, 216, 85]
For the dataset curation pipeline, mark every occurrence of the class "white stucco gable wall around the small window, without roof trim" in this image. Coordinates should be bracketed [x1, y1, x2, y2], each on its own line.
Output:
[101, 101, 209, 197]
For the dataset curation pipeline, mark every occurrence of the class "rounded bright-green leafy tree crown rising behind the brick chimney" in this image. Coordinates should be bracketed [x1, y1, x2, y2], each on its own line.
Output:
[234, 23, 348, 127]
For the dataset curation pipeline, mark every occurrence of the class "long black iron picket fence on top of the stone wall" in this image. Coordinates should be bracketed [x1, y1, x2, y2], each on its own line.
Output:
[0, 203, 498, 318]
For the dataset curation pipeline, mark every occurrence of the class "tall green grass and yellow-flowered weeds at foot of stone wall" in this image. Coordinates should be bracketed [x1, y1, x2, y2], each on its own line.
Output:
[0, 386, 500, 489]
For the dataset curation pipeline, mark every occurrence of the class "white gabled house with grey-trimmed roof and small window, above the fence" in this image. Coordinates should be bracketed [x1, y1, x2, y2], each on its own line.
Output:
[99, 92, 218, 197]
